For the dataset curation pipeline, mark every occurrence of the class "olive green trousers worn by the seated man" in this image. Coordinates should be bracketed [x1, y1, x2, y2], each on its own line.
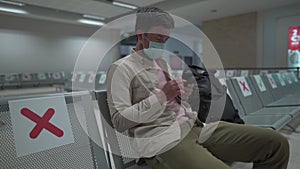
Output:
[146, 122, 289, 169]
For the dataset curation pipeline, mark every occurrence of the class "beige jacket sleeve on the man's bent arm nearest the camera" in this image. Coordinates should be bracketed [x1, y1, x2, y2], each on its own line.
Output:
[107, 64, 165, 132]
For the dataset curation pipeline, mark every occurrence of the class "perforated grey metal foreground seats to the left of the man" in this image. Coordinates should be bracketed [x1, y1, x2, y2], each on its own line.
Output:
[0, 91, 143, 169]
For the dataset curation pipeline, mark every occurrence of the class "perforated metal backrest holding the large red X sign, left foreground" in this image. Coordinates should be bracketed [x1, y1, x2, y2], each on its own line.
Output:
[0, 92, 101, 169]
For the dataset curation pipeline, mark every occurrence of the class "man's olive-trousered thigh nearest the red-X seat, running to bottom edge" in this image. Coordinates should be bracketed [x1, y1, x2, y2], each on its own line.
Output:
[146, 125, 230, 169]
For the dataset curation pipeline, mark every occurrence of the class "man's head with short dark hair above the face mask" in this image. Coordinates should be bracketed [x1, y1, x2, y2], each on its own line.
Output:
[135, 7, 174, 56]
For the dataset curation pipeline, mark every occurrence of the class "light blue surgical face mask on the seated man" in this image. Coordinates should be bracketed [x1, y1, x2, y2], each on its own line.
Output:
[144, 40, 166, 59]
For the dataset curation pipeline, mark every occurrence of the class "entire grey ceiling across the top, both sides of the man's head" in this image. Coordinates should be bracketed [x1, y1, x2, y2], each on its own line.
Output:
[0, 0, 300, 25]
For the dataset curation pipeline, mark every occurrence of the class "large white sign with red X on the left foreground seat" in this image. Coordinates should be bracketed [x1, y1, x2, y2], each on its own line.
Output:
[9, 95, 74, 157]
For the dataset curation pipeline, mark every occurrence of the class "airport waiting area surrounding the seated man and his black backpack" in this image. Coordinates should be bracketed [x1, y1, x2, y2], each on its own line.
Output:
[0, 0, 300, 169]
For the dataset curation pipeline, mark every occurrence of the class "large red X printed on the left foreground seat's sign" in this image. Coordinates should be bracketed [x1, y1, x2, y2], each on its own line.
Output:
[21, 108, 64, 139]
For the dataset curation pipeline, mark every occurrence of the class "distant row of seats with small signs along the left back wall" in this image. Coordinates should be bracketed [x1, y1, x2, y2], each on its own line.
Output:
[0, 71, 106, 91]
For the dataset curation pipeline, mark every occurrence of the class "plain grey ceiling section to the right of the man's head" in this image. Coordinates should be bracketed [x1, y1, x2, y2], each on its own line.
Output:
[171, 0, 300, 24]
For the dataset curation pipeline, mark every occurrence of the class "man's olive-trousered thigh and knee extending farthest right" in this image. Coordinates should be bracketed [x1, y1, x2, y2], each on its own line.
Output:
[202, 122, 285, 162]
